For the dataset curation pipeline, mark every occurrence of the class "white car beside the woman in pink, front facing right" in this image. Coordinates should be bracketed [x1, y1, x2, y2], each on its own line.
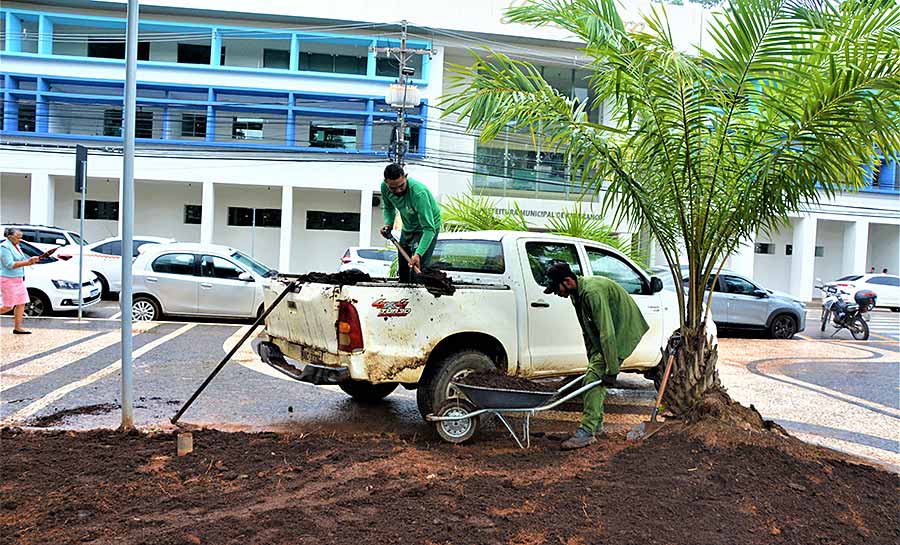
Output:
[1, 241, 100, 316]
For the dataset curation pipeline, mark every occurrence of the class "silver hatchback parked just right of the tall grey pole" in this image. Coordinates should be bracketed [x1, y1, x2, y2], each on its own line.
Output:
[131, 243, 277, 321]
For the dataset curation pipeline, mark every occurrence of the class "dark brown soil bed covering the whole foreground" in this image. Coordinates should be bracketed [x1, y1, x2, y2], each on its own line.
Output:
[0, 426, 900, 545]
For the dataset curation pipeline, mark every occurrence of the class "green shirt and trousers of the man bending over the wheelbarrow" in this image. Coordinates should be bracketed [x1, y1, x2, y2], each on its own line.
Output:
[571, 276, 650, 433]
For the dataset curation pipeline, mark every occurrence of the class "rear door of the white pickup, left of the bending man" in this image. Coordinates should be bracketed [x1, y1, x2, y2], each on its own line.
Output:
[519, 239, 587, 376]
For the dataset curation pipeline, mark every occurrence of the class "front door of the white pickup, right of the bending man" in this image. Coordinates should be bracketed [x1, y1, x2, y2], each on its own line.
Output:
[584, 246, 663, 367]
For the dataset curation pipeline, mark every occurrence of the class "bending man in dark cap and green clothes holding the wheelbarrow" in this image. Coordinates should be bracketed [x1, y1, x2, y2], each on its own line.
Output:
[544, 262, 650, 450]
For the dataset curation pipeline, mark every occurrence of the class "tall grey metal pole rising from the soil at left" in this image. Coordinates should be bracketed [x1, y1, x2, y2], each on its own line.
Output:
[119, 0, 138, 430]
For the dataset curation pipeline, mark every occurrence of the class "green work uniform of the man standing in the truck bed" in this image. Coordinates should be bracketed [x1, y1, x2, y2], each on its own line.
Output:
[381, 178, 441, 268]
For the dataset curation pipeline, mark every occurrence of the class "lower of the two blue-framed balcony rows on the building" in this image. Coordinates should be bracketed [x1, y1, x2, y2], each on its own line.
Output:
[0, 74, 426, 153]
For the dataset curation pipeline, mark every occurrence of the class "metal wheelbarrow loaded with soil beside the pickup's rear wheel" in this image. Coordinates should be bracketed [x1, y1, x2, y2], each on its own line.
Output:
[425, 375, 603, 449]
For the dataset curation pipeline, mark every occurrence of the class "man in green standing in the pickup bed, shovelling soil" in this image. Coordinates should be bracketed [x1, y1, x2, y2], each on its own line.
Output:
[381, 163, 441, 282]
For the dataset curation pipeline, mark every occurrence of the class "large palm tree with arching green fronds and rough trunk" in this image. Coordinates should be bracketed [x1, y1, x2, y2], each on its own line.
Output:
[444, 0, 900, 415]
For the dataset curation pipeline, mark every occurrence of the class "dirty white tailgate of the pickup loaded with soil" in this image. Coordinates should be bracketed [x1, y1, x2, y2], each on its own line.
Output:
[264, 281, 341, 354]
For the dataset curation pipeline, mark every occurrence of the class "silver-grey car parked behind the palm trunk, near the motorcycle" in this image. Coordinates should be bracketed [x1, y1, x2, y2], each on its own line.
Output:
[650, 267, 806, 339]
